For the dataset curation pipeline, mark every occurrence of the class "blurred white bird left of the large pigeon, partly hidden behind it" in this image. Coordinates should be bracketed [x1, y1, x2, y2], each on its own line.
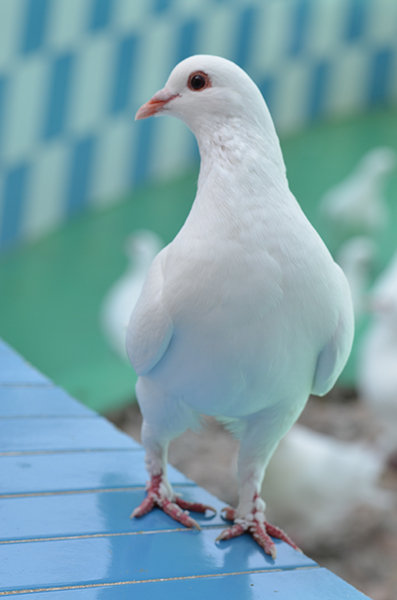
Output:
[100, 229, 164, 360]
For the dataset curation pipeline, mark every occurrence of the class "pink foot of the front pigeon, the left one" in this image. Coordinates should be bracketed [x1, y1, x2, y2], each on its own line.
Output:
[131, 473, 216, 529]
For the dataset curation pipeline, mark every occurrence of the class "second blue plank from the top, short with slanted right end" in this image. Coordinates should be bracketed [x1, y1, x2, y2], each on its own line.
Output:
[0, 385, 95, 418]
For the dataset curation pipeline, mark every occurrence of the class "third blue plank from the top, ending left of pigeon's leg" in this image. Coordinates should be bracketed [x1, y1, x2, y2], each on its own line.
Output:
[0, 416, 137, 452]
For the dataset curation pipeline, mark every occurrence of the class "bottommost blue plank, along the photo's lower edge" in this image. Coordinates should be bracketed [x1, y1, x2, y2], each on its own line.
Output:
[6, 568, 368, 600]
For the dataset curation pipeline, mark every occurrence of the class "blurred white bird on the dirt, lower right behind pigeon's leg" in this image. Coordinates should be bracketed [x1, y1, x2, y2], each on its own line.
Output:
[263, 425, 390, 543]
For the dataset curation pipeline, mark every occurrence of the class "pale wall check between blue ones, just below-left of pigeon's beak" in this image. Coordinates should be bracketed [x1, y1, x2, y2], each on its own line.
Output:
[92, 117, 134, 206]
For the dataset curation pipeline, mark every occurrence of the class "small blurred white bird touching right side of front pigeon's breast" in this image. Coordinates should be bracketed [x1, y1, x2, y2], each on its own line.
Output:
[336, 236, 376, 321]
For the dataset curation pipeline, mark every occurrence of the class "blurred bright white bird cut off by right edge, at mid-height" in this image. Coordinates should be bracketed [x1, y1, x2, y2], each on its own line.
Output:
[358, 253, 397, 452]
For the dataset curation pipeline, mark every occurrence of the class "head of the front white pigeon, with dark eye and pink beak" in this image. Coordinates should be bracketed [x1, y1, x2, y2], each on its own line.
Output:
[135, 55, 270, 133]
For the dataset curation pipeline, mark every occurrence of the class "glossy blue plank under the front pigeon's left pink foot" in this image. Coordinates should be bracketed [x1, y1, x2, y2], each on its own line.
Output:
[0, 486, 225, 541]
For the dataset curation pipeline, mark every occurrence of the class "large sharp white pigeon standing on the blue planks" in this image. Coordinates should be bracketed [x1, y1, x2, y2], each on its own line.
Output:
[127, 55, 354, 557]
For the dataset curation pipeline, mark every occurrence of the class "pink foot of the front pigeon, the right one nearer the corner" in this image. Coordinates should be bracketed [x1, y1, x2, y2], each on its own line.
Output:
[216, 497, 299, 560]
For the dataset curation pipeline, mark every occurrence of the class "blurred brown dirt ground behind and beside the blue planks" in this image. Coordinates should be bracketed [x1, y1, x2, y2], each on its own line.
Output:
[108, 388, 397, 600]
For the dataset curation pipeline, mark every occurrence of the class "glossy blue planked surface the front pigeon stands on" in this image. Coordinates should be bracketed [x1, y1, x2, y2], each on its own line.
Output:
[0, 341, 367, 600]
